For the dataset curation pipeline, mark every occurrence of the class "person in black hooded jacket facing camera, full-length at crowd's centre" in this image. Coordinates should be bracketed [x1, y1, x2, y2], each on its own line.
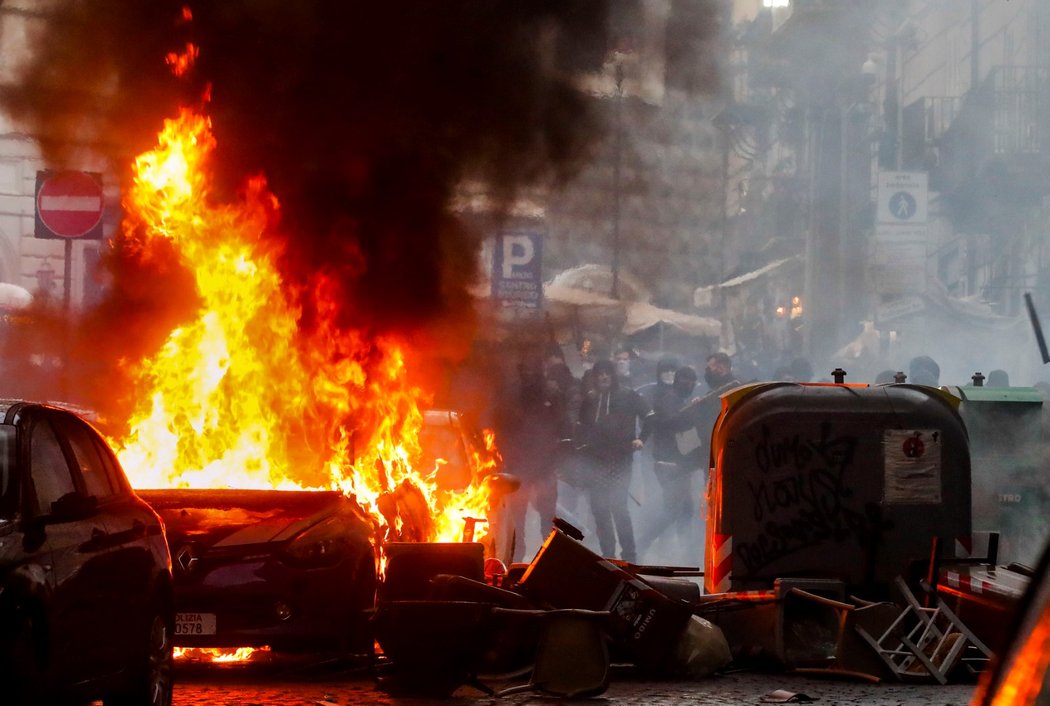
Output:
[576, 360, 649, 562]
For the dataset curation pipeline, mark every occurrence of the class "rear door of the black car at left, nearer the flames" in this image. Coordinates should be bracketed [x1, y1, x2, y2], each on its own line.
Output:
[54, 414, 154, 670]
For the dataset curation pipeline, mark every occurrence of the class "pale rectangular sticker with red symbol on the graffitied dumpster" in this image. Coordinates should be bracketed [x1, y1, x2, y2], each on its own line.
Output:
[882, 429, 942, 504]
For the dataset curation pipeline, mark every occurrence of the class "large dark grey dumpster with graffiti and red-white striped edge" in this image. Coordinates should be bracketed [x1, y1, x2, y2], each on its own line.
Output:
[705, 382, 970, 597]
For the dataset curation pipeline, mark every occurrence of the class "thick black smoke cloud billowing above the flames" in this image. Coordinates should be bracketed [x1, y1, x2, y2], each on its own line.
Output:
[2, 0, 609, 330]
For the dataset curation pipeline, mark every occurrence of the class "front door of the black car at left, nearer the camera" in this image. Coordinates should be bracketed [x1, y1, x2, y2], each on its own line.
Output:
[24, 410, 120, 682]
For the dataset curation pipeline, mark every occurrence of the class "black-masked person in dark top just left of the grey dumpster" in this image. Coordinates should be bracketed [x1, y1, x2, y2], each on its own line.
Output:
[638, 366, 702, 563]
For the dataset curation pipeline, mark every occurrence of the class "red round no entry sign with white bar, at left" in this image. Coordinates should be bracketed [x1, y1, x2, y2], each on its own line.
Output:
[36, 171, 103, 240]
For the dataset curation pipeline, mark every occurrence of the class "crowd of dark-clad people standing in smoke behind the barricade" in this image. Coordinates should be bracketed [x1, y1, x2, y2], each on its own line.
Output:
[472, 346, 1029, 565]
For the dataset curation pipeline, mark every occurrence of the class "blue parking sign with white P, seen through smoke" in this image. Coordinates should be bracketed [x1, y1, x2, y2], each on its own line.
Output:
[492, 230, 543, 309]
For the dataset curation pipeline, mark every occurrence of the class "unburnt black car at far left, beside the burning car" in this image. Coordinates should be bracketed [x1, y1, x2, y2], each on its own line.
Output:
[0, 400, 174, 706]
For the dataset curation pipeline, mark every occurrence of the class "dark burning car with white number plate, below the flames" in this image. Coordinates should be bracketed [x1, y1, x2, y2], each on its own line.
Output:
[140, 490, 376, 652]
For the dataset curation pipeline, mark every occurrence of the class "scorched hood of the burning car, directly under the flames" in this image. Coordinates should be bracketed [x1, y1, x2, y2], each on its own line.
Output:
[137, 489, 368, 551]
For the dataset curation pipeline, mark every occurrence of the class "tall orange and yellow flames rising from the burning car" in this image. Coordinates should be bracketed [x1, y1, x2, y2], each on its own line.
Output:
[113, 105, 491, 541]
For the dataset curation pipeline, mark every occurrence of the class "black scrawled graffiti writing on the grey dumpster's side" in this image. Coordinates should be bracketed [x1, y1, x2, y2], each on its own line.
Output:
[735, 422, 882, 572]
